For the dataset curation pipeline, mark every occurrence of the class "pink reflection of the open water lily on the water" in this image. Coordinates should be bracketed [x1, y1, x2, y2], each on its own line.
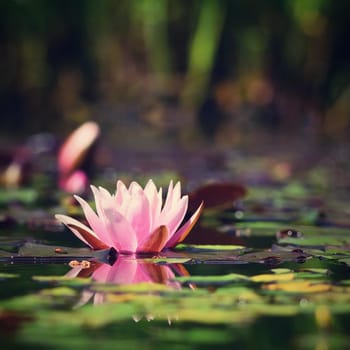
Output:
[66, 256, 193, 323]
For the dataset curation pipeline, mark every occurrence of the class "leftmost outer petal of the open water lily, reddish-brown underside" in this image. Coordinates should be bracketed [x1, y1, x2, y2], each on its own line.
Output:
[55, 214, 108, 249]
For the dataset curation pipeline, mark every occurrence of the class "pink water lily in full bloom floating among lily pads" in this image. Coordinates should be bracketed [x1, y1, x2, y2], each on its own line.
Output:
[56, 180, 203, 253]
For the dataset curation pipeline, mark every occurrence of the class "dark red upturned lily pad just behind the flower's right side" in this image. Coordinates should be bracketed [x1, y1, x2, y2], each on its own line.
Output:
[189, 182, 247, 212]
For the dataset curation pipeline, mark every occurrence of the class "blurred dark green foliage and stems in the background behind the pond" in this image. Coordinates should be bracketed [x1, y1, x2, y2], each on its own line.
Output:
[0, 0, 350, 144]
